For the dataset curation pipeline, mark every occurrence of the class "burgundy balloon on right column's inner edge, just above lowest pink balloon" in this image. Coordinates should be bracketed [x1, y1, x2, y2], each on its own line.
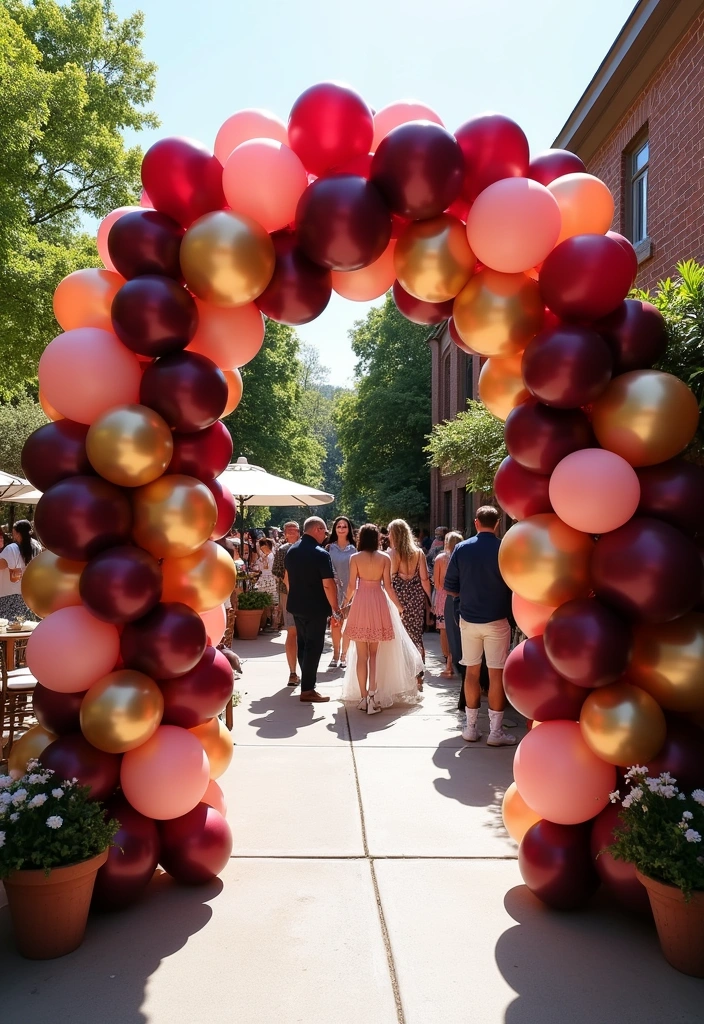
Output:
[503, 637, 586, 722]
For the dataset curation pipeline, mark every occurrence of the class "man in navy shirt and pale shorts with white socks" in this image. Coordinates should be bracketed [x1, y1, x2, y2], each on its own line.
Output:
[444, 505, 516, 746]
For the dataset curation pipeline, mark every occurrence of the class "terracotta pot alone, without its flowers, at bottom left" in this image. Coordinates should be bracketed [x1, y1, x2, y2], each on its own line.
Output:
[5, 850, 108, 959]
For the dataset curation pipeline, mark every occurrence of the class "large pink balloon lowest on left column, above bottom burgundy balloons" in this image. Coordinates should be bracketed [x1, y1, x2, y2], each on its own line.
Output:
[120, 725, 210, 821]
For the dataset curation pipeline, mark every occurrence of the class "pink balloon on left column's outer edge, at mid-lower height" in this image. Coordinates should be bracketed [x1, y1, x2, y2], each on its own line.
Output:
[27, 605, 120, 693]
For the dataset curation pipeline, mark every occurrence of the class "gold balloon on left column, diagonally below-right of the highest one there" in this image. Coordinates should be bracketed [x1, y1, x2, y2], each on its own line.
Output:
[132, 473, 218, 558]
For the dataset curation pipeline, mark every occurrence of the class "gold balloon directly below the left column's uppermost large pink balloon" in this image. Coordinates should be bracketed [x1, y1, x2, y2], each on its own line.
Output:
[86, 406, 174, 487]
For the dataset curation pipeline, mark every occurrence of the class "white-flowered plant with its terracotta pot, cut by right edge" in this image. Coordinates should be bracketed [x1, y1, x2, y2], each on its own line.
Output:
[609, 767, 704, 978]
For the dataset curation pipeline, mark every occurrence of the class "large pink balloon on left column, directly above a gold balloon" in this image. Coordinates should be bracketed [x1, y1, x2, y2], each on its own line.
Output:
[39, 327, 142, 423]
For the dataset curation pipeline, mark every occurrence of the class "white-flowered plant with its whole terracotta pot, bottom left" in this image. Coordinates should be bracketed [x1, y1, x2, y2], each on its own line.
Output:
[0, 761, 119, 959]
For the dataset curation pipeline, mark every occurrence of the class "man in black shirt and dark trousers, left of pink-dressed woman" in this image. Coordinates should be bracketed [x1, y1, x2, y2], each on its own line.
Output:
[283, 516, 342, 703]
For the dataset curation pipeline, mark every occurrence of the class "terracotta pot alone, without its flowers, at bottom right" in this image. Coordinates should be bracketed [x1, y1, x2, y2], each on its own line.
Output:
[635, 871, 704, 978]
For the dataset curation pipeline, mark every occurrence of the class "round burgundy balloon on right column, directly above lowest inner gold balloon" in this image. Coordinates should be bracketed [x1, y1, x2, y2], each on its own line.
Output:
[542, 597, 633, 689]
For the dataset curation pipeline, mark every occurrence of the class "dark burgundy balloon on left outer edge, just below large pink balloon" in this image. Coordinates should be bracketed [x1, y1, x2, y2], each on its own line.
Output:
[21, 420, 95, 490]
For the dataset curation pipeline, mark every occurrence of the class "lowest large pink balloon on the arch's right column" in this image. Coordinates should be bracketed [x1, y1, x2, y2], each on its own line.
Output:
[511, 720, 616, 825]
